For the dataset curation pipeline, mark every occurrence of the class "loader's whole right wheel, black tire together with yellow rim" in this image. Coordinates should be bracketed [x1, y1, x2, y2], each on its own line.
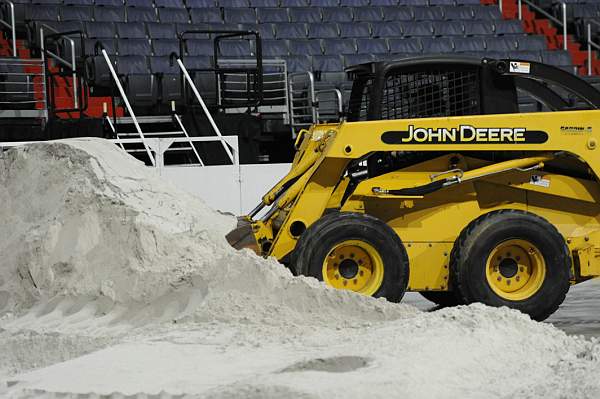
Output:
[451, 210, 571, 320]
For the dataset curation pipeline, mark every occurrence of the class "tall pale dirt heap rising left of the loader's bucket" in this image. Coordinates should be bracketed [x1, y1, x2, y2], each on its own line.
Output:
[0, 139, 414, 325]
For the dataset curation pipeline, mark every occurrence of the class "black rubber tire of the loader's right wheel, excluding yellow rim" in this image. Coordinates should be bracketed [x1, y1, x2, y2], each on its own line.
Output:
[450, 210, 571, 321]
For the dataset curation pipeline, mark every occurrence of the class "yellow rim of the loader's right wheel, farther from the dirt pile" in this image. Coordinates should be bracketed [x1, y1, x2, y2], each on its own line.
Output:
[486, 239, 546, 301]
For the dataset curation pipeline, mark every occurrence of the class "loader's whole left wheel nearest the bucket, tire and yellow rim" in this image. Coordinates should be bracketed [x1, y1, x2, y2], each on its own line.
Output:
[292, 212, 409, 302]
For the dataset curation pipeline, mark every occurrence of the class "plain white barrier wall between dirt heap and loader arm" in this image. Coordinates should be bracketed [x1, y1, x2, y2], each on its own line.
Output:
[159, 164, 291, 215]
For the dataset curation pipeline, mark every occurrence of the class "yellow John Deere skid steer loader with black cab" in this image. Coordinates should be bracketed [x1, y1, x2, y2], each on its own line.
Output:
[227, 57, 600, 320]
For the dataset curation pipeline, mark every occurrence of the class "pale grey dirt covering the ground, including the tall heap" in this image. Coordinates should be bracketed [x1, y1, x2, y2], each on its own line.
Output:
[0, 139, 600, 399]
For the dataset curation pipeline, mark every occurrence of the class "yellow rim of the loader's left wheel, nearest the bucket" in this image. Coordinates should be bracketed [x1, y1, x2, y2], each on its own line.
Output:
[323, 240, 383, 296]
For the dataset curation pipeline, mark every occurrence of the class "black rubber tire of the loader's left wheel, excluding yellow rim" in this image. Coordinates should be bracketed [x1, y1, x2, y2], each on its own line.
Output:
[292, 212, 409, 302]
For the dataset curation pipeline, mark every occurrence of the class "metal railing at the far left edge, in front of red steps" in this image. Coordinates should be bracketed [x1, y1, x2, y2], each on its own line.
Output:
[0, 57, 47, 118]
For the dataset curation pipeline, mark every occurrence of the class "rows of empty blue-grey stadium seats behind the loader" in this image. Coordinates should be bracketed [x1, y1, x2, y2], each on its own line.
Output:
[7, 0, 576, 108]
